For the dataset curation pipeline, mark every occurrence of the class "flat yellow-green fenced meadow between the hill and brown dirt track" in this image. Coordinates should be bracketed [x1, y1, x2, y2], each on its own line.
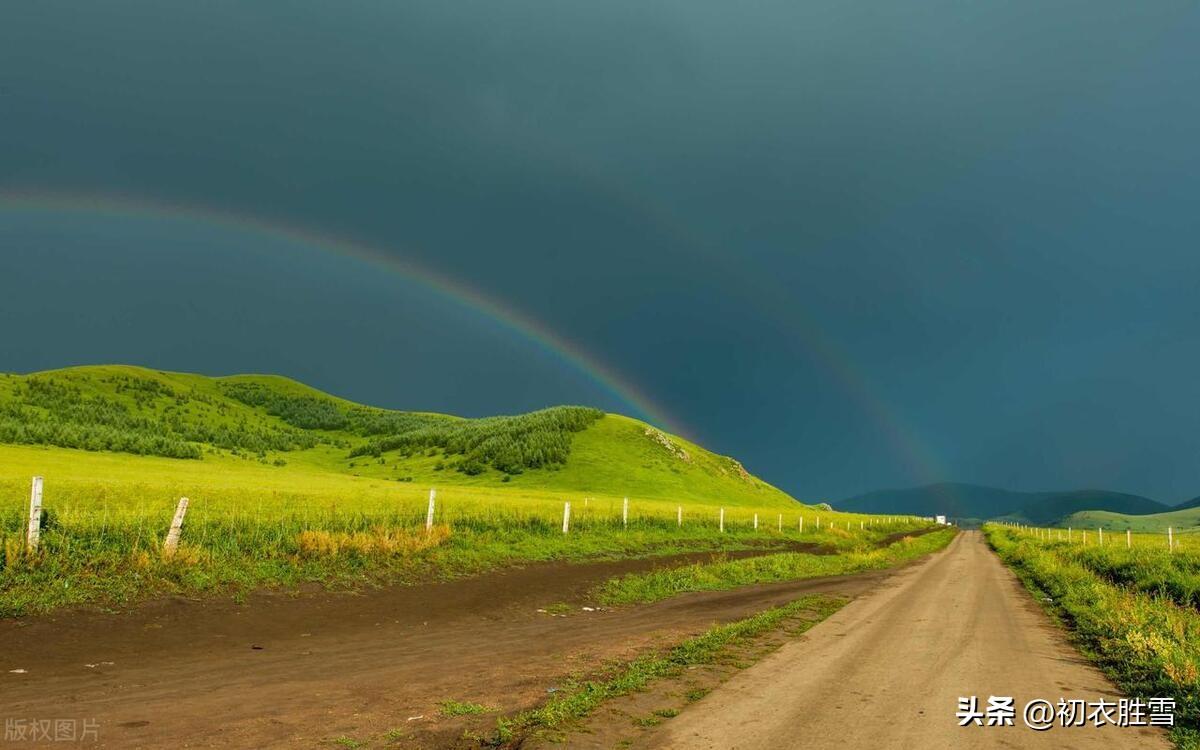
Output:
[0, 446, 916, 617]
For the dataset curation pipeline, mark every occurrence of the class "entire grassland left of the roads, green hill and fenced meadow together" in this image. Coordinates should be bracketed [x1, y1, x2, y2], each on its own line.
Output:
[0, 367, 912, 617]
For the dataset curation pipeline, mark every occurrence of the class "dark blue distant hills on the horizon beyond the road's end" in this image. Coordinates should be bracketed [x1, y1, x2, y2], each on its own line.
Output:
[833, 482, 1176, 524]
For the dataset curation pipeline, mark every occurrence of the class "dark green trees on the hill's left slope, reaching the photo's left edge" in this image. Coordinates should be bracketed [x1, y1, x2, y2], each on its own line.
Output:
[0, 376, 317, 458]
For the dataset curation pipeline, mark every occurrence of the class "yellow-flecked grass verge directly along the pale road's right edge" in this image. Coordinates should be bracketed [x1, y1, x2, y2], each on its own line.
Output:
[984, 524, 1200, 750]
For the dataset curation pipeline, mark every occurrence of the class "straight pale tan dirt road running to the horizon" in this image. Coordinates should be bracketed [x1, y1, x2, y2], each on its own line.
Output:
[646, 532, 1170, 750]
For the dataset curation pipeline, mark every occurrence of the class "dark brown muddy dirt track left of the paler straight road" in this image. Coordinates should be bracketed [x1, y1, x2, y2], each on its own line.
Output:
[0, 544, 893, 750]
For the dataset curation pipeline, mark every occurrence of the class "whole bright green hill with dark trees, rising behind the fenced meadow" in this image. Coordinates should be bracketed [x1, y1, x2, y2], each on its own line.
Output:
[0, 365, 793, 505]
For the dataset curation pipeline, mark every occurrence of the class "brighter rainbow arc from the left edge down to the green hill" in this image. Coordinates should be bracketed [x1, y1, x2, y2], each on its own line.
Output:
[0, 191, 689, 437]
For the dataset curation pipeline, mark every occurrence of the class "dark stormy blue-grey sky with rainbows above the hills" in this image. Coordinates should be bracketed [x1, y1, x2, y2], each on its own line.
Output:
[0, 0, 1200, 502]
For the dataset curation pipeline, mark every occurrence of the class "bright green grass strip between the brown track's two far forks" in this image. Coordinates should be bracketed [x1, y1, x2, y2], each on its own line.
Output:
[595, 528, 958, 606]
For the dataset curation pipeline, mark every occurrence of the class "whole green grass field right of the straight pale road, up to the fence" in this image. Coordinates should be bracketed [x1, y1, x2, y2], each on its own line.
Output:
[984, 524, 1200, 749]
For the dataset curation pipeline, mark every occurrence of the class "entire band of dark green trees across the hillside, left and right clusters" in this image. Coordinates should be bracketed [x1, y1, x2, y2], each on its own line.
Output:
[0, 374, 604, 475]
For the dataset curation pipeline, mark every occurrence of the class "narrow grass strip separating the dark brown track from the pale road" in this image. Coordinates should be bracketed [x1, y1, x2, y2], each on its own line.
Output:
[485, 595, 846, 746]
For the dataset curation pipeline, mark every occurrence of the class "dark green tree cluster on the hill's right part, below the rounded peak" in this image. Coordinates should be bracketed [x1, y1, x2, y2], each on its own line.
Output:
[350, 407, 604, 474]
